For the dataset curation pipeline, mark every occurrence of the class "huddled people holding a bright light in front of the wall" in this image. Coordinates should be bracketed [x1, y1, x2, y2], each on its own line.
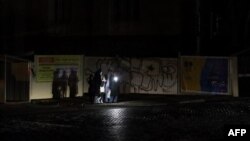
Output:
[88, 69, 120, 103]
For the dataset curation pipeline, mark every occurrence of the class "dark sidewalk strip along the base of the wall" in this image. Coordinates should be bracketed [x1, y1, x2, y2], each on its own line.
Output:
[28, 94, 250, 107]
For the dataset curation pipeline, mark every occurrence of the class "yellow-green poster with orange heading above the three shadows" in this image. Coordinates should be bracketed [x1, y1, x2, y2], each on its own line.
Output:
[35, 55, 82, 82]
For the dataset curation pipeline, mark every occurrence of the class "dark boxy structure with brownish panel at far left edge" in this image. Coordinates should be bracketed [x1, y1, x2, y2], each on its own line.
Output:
[0, 55, 30, 103]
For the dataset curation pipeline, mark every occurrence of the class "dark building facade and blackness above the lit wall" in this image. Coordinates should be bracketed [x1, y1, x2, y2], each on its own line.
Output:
[0, 0, 250, 58]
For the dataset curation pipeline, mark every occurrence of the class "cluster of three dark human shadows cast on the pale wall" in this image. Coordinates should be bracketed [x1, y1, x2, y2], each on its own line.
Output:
[52, 69, 79, 99]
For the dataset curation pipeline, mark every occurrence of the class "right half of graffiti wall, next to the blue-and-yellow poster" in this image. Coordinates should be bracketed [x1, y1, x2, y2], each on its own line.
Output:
[130, 59, 177, 94]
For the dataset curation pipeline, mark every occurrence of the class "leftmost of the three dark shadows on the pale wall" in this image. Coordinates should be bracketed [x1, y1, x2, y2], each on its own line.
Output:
[52, 69, 61, 99]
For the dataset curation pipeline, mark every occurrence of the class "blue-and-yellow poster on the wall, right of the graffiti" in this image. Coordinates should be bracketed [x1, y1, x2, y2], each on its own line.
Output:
[180, 57, 229, 94]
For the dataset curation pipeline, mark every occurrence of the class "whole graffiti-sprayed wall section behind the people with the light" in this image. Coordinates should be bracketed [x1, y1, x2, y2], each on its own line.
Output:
[84, 57, 177, 94]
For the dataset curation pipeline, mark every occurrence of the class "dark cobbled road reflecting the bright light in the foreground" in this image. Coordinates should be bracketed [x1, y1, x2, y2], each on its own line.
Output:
[0, 96, 250, 141]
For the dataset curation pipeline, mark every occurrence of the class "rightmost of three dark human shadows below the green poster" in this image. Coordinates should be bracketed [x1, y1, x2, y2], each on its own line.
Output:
[68, 69, 79, 98]
